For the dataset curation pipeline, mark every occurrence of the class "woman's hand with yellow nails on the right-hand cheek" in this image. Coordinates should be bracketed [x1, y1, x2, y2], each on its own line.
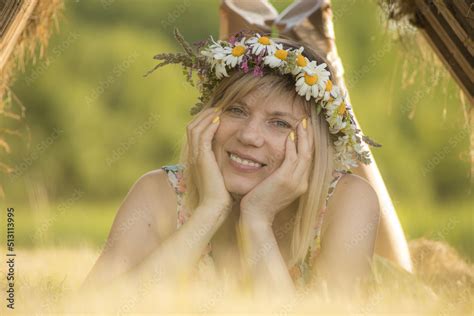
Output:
[240, 119, 314, 225]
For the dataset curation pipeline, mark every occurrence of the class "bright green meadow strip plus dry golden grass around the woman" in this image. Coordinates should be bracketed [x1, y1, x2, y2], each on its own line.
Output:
[0, 201, 474, 315]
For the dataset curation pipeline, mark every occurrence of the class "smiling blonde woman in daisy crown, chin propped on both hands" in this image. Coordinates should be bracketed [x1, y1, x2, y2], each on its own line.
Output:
[86, 33, 379, 295]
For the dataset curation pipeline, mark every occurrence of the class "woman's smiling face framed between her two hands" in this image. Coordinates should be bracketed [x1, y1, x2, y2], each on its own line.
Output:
[213, 90, 305, 196]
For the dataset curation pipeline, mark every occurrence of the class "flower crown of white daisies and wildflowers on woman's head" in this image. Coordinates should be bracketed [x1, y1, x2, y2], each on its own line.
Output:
[145, 29, 381, 172]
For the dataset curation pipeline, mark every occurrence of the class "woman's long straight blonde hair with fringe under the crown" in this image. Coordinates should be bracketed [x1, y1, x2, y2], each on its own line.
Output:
[180, 39, 334, 266]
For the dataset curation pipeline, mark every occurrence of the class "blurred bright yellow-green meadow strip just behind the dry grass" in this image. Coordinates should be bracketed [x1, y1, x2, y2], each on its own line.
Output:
[0, 201, 474, 262]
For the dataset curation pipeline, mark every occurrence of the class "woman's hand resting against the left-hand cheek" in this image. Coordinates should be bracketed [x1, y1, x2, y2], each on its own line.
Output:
[187, 107, 233, 218]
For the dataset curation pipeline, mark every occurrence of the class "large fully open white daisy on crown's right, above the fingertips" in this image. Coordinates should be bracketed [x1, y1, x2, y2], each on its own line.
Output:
[295, 60, 329, 101]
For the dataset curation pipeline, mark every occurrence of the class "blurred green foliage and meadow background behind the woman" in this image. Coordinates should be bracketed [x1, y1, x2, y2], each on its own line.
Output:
[1, 0, 474, 261]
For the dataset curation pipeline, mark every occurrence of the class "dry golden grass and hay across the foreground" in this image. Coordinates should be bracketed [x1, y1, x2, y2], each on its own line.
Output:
[0, 239, 474, 315]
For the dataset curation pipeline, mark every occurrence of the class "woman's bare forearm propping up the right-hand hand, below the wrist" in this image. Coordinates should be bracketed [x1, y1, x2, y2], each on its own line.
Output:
[239, 215, 295, 297]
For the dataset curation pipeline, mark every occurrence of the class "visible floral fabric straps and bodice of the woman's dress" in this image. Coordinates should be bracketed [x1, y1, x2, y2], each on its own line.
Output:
[161, 164, 345, 288]
